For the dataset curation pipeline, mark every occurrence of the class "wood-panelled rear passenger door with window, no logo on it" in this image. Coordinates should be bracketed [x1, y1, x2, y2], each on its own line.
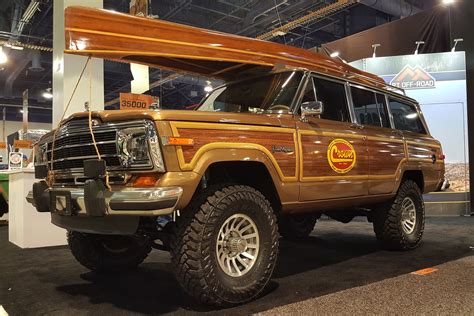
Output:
[350, 85, 405, 195]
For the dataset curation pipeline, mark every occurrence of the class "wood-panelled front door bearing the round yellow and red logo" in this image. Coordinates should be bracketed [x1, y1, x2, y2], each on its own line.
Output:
[297, 77, 368, 201]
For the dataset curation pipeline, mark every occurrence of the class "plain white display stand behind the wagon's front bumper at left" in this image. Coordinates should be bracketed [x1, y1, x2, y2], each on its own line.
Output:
[6, 169, 67, 248]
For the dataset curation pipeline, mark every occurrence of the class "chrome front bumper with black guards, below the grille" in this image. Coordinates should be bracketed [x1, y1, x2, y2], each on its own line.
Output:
[26, 183, 183, 217]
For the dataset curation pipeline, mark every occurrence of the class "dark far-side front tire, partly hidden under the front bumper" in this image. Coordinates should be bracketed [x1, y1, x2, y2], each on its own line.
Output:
[67, 231, 152, 272]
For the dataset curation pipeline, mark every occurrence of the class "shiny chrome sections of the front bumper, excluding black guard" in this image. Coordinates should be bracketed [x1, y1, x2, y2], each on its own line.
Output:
[26, 187, 183, 216]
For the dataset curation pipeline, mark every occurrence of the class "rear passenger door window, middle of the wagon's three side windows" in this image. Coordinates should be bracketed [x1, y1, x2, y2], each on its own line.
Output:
[351, 87, 382, 127]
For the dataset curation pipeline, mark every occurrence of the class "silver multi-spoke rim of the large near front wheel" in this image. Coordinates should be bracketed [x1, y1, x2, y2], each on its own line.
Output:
[216, 214, 260, 277]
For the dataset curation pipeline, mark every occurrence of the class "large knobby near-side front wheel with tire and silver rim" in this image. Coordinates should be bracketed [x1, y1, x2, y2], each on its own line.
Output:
[171, 185, 279, 306]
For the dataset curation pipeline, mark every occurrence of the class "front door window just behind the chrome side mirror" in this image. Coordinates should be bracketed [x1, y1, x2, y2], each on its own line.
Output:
[313, 78, 351, 122]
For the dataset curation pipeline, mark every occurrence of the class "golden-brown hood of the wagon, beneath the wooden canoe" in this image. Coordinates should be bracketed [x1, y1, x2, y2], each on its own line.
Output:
[61, 110, 295, 127]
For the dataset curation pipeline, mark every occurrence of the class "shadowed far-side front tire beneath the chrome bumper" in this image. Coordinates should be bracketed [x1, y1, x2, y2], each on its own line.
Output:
[67, 231, 151, 272]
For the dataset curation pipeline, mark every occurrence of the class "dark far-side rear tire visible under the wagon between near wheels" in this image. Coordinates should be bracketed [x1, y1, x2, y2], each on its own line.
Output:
[278, 214, 320, 240]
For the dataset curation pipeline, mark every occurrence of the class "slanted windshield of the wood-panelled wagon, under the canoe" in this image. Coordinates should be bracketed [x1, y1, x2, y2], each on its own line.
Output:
[197, 71, 303, 113]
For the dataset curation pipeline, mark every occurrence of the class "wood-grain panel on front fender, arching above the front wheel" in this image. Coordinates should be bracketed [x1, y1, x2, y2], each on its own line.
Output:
[178, 128, 297, 177]
